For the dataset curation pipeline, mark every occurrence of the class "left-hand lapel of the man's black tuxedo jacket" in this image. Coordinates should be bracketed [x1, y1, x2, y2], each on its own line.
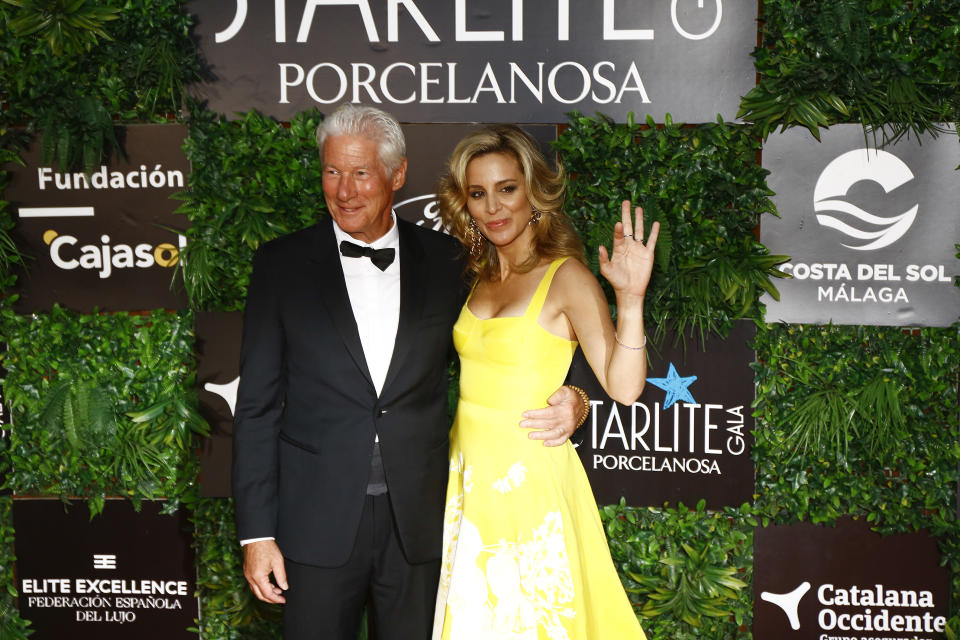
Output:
[310, 219, 376, 387]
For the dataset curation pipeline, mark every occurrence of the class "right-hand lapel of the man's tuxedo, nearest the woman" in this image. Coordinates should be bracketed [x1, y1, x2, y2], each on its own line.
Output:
[381, 219, 427, 396]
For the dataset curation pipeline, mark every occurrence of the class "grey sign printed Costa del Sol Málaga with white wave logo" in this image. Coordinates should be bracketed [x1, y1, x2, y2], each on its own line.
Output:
[760, 124, 960, 326]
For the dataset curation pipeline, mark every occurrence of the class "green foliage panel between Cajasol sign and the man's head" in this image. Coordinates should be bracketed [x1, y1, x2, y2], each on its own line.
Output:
[178, 110, 326, 311]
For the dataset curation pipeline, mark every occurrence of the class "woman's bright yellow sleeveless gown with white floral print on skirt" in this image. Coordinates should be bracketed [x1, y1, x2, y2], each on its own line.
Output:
[433, 259, 645, 640]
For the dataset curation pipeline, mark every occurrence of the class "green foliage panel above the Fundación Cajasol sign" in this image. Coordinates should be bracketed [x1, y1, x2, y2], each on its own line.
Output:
[0, 0, 200, 170]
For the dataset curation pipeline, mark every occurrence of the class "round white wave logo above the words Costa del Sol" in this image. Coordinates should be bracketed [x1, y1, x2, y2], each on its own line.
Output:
[813, 149, 920, 251]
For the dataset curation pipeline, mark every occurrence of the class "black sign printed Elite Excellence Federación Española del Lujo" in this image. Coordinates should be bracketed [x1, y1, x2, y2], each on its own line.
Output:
[13, 500, 198, 640]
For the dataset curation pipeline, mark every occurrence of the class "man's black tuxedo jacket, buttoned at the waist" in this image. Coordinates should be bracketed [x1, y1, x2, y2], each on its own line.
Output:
[233, 219, 464, 566]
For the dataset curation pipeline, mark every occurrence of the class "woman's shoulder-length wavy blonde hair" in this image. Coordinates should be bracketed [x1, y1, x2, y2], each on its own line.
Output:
[438, 124, 586, 280]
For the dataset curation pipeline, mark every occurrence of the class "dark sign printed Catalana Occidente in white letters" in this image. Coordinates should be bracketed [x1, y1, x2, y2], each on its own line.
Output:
[753, 518, 950, 640]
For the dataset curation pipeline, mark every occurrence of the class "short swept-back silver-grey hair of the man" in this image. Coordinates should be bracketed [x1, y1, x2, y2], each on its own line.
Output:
[317, 103, 407, 175]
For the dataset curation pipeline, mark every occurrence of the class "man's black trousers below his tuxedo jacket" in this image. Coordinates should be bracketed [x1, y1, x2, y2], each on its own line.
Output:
[283, 494, 440, 640]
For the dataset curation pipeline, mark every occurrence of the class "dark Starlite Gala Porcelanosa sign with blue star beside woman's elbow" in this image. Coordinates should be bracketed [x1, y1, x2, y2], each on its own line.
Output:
[571, 321, 755, 508]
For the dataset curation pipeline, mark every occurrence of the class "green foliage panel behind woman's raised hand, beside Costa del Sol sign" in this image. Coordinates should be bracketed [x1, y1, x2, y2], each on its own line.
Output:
[555, 115, 787, 336]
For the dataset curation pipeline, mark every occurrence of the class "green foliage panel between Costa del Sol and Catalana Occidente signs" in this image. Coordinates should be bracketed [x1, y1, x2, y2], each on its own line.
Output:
[753, 323, 960, 616]
